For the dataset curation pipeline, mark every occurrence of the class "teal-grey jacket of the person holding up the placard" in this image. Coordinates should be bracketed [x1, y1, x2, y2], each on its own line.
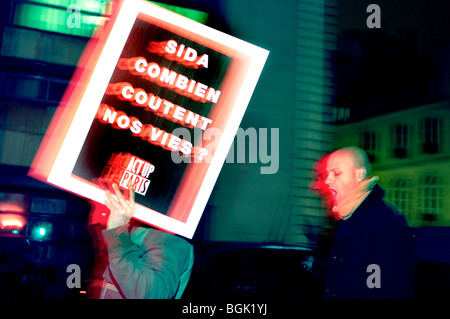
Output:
[102, 225, 193, 299]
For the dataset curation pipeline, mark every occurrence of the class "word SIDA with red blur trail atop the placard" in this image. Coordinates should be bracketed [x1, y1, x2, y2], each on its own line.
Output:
[147, 40, 208, 69]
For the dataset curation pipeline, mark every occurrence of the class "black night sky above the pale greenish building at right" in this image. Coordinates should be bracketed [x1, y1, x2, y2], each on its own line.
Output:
[336, 0, 450, 120]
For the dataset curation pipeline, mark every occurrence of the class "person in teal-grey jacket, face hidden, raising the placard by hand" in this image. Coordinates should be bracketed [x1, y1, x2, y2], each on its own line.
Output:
[93, 183, 193, 299]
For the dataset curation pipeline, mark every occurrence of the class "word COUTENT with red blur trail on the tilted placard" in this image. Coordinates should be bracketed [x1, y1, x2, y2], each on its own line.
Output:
[106, 82, 212, 130]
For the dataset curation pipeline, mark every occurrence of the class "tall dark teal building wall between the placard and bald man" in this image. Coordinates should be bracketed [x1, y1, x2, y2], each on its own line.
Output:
[202, 0, 337, 247]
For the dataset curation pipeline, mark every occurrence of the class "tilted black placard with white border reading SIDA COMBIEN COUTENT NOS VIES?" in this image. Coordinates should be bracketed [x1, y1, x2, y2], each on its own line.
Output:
[30, 0, 269, 238]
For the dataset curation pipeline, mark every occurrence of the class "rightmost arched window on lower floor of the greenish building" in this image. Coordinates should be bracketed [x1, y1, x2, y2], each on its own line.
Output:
[419, 175, 442, 223]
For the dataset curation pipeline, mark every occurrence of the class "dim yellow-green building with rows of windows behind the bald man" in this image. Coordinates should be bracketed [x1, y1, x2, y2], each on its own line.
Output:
[336, 101, 450, 227]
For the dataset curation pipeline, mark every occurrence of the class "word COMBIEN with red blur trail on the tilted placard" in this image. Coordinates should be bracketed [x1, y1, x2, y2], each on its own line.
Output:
[117, 57, 221, 103]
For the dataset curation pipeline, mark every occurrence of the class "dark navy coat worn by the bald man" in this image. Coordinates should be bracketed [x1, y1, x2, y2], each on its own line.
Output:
[324, 185, 414, 299]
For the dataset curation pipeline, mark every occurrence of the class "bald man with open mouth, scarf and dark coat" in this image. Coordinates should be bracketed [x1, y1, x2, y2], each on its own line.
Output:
[324, 147, 414, 299]
